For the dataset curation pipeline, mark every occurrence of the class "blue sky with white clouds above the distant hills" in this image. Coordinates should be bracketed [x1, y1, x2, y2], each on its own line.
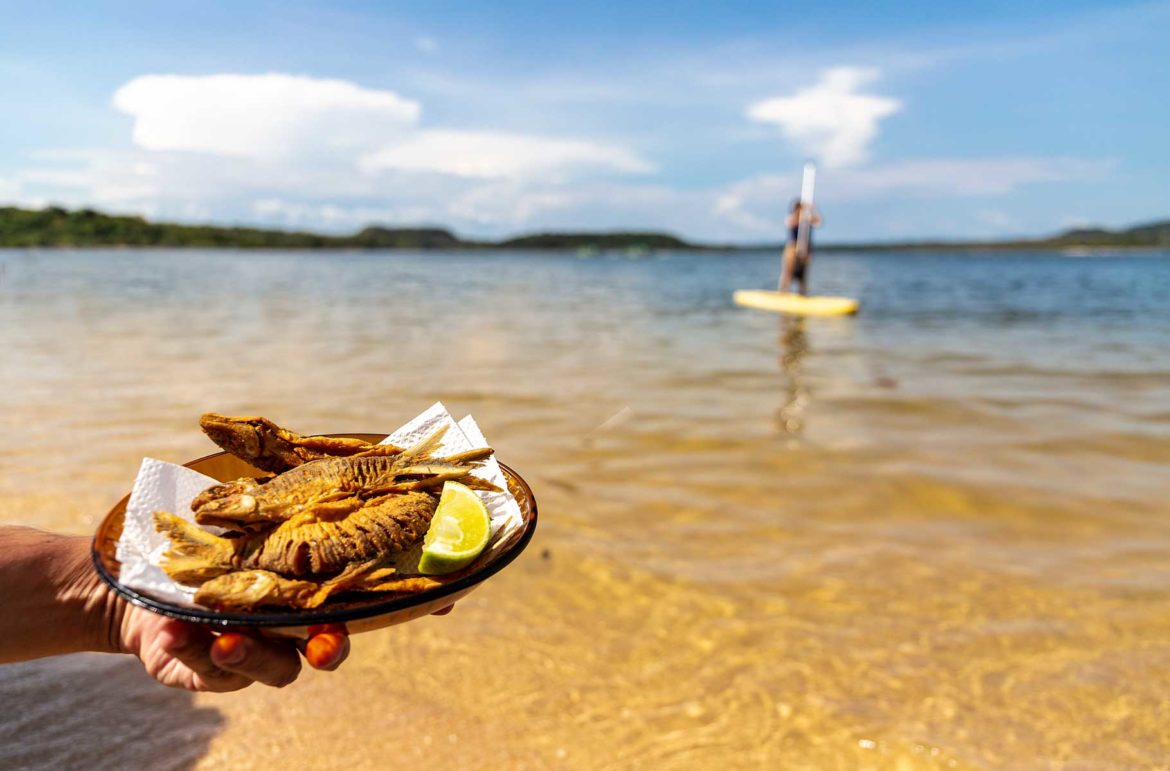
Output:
[0, 0, 1170, 243]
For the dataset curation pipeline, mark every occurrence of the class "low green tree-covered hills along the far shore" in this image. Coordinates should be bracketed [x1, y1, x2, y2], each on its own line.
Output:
[0, 206, 1170, 252]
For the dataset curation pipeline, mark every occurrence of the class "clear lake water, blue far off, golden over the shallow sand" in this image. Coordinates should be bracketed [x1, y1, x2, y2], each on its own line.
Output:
[0, 250, 1170, 769]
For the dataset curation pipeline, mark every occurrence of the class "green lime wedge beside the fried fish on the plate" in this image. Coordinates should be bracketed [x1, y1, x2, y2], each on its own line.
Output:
[419, 482, 491, 576]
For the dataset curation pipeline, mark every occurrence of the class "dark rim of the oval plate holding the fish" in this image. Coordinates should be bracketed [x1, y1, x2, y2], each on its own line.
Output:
[90, 433, 537, 627]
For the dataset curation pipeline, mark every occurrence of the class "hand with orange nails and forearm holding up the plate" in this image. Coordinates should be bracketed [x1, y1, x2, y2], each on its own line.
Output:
[0, 525, 349, 691]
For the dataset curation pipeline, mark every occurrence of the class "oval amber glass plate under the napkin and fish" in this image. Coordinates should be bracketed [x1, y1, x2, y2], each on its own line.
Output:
[94, 434, 536, 639]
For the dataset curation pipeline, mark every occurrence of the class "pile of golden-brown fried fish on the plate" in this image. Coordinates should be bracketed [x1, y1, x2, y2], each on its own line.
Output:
[154, 415, 497, 610]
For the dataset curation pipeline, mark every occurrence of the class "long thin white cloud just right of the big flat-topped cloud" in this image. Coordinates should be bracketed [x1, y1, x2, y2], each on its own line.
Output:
[362, 131, 652, 179]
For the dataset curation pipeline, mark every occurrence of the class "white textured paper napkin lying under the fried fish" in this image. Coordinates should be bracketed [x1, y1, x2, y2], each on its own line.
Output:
[117, 401, 524, 607]
